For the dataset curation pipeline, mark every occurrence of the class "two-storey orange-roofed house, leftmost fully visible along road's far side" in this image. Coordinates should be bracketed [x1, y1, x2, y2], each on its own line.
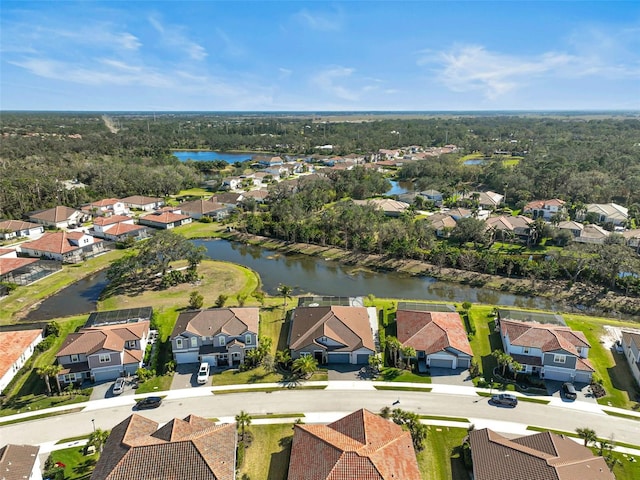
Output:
[56, 321, 149, 385]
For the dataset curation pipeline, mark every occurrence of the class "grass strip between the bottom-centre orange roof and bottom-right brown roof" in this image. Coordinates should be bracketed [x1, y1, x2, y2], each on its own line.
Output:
[417, 425, 469, 480]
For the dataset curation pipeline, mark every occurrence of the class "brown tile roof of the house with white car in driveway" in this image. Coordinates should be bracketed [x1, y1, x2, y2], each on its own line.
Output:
[171, 307, 260, 338]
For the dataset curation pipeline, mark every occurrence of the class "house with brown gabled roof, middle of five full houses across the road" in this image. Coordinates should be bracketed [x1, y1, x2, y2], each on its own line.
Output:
[287, 305, 377, 365]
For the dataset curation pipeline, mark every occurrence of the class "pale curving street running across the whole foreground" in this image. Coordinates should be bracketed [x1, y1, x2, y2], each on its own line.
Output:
[0, 389, 640, 445]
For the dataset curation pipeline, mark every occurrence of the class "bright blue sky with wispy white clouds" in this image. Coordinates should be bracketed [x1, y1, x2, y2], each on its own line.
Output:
[0, 0, 640, 111]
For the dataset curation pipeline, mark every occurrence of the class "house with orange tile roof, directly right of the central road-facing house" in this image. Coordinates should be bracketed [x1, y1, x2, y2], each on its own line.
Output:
[396, 309, 473, 369]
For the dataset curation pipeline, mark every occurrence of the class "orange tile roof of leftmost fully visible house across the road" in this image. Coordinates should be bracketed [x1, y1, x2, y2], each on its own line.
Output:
[56, 321, 149, 357]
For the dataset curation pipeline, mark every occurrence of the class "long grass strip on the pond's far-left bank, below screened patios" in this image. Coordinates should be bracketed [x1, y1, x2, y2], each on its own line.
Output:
[0, 250, 126, 325]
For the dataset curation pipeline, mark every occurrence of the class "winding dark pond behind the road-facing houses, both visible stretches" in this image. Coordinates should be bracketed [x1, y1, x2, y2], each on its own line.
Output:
[25, 240, 562, 321]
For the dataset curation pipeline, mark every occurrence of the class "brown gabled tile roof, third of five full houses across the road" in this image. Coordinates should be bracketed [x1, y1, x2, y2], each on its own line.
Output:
[289, 306, 376, 352]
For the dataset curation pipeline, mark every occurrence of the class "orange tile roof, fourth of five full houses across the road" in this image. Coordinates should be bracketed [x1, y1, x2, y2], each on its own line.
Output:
[396, 310, 473, 356]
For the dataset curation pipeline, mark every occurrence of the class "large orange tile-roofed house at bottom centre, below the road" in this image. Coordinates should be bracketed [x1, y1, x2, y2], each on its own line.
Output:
[287, 409, 422, 480]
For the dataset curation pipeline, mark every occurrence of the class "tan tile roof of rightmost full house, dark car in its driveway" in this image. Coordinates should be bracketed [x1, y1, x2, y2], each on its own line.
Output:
[500, 320, 591, 356]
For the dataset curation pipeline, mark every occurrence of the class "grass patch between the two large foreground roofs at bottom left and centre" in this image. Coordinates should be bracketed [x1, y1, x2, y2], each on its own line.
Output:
[238, 423, 293, 480]
